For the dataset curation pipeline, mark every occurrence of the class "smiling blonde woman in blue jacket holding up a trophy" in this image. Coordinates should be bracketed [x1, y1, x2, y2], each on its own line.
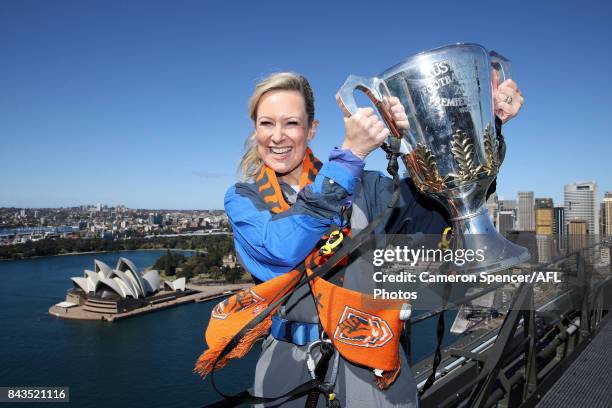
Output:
[225, 73, 522, 407]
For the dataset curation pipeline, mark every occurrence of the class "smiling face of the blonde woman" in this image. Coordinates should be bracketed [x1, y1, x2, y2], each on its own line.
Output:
[255, 90, 317, 185]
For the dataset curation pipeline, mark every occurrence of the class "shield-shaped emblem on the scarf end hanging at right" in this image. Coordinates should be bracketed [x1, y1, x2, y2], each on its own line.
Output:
[334, 306, 393, 347]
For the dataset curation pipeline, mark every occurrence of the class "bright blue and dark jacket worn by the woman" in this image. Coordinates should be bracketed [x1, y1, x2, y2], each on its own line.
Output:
[225, 148, 449, 281]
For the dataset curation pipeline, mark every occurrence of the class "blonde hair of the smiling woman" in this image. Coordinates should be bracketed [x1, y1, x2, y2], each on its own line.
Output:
[239, 72, 314, 180]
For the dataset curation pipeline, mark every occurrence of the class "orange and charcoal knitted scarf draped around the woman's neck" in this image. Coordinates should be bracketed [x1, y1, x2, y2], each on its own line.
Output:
[194, 149, 403, 389]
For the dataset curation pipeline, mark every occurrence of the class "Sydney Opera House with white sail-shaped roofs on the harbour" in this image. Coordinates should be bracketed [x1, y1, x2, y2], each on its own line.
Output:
[56, 258, 191, 317]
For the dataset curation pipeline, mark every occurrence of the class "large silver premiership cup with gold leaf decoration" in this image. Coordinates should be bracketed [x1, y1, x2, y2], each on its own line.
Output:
[337, 44, 529, 273]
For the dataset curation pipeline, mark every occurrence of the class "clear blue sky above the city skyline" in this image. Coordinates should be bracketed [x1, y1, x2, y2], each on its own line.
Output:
[0, 0, 612, 209]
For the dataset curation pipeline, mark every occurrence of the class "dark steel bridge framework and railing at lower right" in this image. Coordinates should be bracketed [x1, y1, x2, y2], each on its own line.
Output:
[408, 236, 612, 407]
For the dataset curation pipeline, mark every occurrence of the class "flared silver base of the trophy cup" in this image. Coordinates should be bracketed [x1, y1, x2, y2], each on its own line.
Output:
[453, 206, 531, 274]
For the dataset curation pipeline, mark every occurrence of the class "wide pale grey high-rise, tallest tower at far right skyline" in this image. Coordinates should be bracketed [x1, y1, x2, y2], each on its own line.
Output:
[564, 181, 599, 235]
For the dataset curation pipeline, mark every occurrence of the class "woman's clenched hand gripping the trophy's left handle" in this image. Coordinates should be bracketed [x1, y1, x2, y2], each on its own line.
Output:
[342, 108, 389, 160]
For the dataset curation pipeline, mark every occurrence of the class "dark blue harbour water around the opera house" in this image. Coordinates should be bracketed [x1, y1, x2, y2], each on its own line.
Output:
[0, 251, 452, 408]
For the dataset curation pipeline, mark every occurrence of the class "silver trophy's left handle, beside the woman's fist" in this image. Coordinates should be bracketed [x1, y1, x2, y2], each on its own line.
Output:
[336, 75, 402, 139]
